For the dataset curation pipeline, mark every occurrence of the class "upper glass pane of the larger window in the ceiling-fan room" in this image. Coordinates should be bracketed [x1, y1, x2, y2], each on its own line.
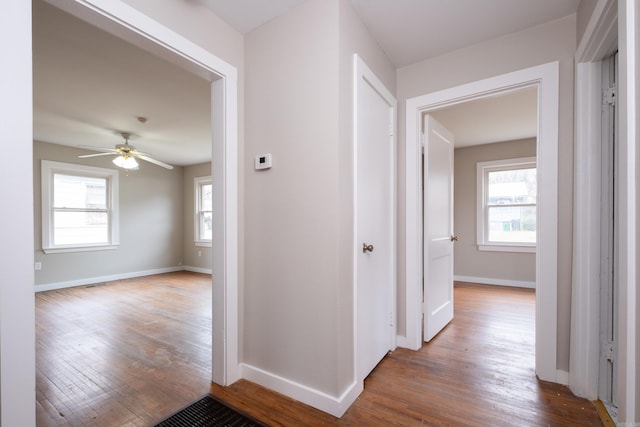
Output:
[53, 174, 107, 209]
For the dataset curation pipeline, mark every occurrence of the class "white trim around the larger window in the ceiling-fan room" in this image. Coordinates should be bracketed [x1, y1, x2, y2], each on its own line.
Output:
[41, 160, 120, 254]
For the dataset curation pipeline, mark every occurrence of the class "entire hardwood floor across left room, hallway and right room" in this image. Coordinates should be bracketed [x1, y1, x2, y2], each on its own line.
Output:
[36, 272, 602, 426]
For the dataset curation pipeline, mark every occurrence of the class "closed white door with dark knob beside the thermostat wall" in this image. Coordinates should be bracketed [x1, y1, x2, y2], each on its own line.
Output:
[355, 56, 395, 380]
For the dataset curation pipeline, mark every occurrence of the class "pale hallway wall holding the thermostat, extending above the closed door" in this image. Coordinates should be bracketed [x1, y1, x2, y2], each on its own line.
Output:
[241, 0, 395, 410]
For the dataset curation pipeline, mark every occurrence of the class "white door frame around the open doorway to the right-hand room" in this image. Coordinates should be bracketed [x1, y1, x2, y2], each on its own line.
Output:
[402, 61, 566, 383]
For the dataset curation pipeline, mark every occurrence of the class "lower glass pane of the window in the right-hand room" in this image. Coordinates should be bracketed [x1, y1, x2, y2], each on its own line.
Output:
[488, 206, 536, 243]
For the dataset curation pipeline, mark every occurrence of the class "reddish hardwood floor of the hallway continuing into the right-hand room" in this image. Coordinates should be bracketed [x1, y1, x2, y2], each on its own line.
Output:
[211, 283, 602, 426]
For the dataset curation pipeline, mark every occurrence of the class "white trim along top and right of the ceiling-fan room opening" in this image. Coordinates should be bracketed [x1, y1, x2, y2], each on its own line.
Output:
[47, 0, 240, 385]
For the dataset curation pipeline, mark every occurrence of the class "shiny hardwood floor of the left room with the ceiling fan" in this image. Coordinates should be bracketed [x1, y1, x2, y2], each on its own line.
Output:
[36, 272, 211, 426]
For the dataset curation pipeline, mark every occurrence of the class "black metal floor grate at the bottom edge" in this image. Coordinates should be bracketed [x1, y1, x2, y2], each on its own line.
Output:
[155, 395, 262, 427]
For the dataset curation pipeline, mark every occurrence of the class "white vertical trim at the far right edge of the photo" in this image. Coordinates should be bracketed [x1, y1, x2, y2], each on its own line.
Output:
[614, 0, 640, 426]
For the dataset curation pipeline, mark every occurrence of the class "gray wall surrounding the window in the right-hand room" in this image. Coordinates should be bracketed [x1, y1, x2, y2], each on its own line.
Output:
[454, 138, 536, 282]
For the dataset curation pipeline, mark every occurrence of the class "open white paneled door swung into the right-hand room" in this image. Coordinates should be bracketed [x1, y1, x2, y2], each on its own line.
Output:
[423, 115, 457, 341]
